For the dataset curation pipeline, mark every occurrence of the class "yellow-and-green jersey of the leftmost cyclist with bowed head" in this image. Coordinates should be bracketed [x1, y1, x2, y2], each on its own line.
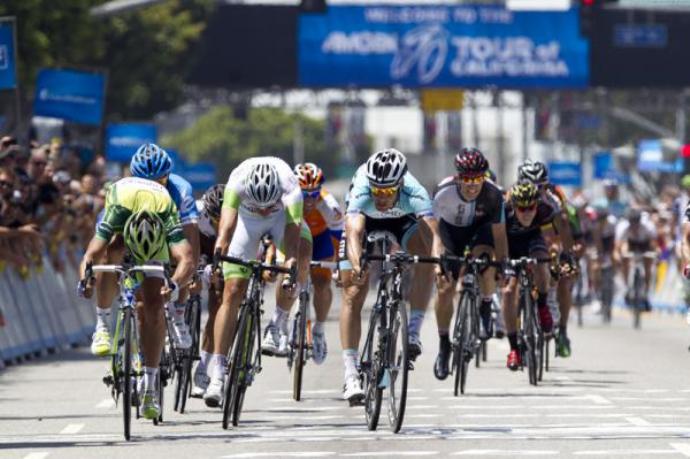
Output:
[96, 177, 185, 244]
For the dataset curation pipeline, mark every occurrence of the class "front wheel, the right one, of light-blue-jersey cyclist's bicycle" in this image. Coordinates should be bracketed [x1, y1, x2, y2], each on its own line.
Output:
[386, 303, 410, 433]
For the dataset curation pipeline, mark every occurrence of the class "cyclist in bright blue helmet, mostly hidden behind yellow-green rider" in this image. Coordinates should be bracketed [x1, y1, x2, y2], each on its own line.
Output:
[129, 143, 199, 349]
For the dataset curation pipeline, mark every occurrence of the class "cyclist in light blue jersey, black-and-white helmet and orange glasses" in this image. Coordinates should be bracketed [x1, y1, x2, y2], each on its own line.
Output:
[339, 148, 442, 405]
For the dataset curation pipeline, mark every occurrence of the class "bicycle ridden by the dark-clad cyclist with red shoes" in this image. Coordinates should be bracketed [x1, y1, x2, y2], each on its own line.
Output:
[508, 257, 552, 386]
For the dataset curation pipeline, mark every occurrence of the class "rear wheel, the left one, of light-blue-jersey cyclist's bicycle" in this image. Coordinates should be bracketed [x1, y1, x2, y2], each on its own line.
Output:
[361, 306, 383, 430]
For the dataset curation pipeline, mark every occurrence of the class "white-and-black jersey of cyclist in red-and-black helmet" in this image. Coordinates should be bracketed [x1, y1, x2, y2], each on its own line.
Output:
[433, 176, 505, 227]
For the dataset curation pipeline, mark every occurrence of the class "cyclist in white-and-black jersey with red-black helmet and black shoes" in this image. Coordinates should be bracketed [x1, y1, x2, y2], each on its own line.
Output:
[433, 148, 508, 379]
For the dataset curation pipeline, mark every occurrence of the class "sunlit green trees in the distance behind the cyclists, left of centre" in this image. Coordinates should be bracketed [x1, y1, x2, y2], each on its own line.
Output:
[161, 106, 338, 174]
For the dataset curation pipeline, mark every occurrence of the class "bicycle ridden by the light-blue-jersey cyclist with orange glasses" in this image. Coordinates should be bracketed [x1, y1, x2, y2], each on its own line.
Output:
[360, 231, 440, 433]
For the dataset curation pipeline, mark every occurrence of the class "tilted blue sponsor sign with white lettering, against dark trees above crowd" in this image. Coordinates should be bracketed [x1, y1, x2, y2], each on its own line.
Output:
[34, 69, 105, 125]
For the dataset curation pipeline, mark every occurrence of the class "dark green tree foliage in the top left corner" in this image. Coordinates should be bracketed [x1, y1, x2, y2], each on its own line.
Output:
[0, 0, 212, 119]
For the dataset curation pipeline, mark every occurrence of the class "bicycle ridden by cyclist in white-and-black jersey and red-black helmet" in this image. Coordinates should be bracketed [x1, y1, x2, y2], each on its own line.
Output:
[443, 255, 500, 397]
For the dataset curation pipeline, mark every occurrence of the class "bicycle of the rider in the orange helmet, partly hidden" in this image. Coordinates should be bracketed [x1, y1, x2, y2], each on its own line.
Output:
[287, 261, 337, 402]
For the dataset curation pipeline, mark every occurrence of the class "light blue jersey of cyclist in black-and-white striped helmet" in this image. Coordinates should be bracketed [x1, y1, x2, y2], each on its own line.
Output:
[347, 164, 433, 219]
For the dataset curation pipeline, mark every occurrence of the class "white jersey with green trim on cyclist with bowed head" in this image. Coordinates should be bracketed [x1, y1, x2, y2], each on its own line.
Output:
[223, 156, 303, 225]
